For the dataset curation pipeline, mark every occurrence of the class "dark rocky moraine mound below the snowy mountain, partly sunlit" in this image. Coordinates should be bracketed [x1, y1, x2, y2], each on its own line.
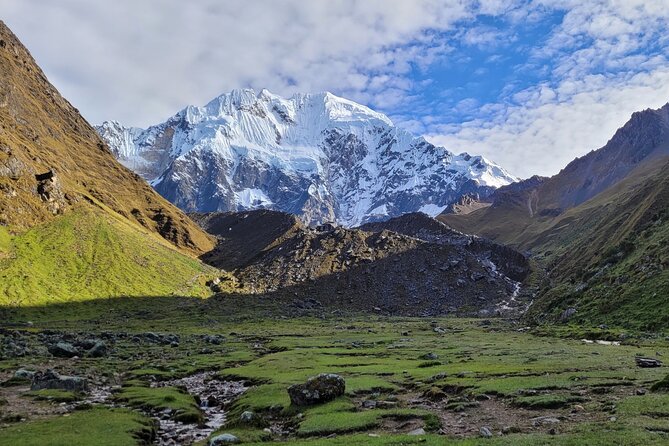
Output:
[194, 210, 529, 316]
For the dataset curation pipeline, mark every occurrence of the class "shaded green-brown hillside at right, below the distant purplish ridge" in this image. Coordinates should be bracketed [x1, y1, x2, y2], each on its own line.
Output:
[440, 158, 669, 329]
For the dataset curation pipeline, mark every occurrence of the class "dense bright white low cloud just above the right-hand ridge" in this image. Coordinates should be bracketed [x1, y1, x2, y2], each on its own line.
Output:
[428, 67, 669, 177]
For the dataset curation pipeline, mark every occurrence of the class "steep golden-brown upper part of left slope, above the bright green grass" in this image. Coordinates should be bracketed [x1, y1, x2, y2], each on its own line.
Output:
[0, 22, 211, 253]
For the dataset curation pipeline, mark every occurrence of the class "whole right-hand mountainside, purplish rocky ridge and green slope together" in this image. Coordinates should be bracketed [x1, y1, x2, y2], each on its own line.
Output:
[438, 105, 669, 328]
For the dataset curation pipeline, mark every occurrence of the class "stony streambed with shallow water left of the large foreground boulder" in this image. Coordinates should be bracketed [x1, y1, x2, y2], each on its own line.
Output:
[151, 372, 246, 446]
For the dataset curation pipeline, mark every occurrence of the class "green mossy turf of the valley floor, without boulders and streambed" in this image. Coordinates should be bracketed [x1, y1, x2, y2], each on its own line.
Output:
[0, 298, 669, 446]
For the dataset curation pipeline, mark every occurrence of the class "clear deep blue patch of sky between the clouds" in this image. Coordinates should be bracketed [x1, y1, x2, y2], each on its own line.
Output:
[386, 11, 564, 133]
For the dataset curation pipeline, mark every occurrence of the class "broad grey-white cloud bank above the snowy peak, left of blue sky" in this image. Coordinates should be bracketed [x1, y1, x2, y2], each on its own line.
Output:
[3, 0, 472, 125]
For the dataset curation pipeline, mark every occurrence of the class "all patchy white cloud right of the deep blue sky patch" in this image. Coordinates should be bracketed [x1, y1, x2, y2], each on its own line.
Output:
[428, 0, 669, 177]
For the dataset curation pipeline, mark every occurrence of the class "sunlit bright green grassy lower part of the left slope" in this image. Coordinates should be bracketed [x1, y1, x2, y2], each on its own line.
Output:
[0, 207, 213, 306]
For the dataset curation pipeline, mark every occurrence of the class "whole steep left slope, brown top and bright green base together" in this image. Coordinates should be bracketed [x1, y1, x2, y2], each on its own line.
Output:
[0, 21, 219, 306]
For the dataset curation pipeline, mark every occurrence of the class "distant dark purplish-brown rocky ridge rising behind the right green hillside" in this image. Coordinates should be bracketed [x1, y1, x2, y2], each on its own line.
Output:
[439, 104, 669, 249]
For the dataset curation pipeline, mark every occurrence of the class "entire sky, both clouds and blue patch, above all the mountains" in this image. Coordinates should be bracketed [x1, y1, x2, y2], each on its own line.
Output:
[2, 0, 669, 177]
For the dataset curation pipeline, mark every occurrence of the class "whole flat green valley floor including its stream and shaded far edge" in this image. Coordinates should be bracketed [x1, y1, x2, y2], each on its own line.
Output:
[0, 297, 669, 446]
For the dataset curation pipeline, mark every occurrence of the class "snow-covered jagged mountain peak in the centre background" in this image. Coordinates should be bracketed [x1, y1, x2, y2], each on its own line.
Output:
[97, 90, 516, 226]
